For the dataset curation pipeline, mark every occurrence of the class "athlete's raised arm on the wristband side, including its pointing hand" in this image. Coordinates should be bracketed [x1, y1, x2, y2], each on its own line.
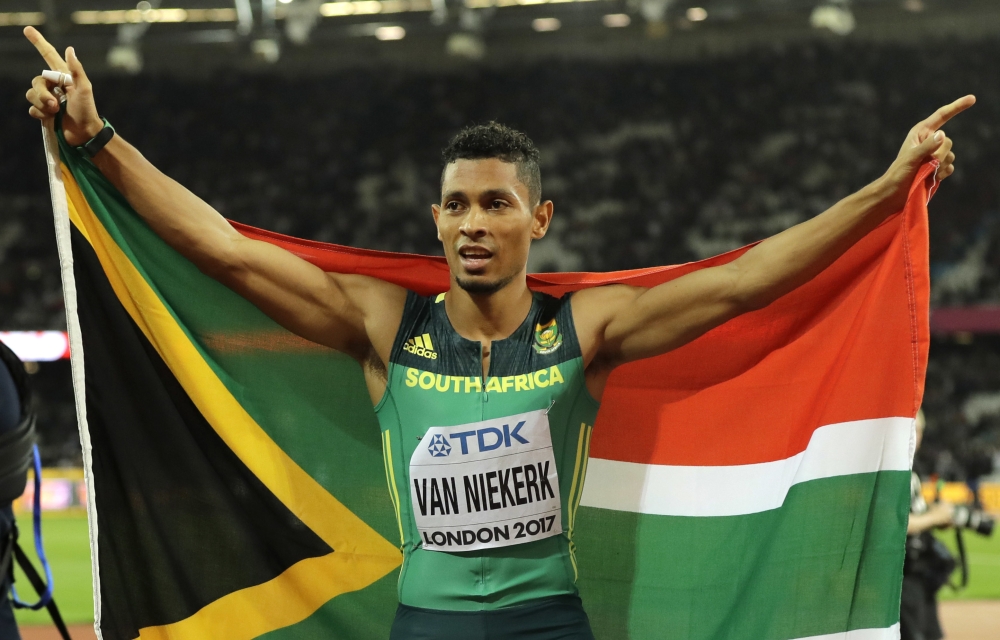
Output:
[25, 27, 405, 360]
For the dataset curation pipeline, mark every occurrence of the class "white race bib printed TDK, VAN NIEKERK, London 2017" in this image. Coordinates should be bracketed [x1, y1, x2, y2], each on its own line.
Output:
[410, 410, 562, 551]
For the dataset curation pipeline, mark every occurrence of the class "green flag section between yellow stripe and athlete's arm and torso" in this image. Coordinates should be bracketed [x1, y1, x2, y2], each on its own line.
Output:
[62, 138, 399, 540]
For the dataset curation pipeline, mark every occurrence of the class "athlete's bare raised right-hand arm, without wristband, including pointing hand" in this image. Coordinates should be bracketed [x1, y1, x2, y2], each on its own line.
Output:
[574, 96, 975, 373]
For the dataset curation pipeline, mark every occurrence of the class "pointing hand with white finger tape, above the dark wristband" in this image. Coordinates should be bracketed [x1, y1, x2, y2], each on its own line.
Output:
[24, 27, 104, 147]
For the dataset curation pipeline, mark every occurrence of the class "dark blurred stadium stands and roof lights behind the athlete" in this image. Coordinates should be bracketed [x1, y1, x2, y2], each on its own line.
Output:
[0, 0, 1000, 638]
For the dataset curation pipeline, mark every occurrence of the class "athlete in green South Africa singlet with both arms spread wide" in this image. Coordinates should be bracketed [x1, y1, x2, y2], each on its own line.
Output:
[25, 27, 975, 640]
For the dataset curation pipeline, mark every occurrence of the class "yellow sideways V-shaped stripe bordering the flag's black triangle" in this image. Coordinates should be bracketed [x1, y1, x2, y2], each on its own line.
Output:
[62, 165, 401, 640]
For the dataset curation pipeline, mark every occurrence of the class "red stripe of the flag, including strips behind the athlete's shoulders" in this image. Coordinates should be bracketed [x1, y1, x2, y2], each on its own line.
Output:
[233, 163, 937, 466]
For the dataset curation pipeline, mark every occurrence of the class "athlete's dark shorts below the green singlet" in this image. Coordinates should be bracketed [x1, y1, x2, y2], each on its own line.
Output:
[389, 596, 594, 640]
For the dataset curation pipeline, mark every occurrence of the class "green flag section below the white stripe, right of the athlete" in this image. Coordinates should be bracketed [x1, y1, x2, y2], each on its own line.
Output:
[575, 471, 910, 640]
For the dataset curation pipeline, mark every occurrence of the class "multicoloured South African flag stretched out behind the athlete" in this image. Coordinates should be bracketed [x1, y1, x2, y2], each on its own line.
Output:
[45, 121, 937, 640]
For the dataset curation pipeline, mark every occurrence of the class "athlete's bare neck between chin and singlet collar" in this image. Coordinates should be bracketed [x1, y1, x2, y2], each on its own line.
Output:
[444, 275, 531, 345]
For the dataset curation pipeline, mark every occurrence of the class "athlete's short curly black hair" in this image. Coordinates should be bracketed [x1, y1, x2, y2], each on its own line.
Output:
[441, 121, 542, 204]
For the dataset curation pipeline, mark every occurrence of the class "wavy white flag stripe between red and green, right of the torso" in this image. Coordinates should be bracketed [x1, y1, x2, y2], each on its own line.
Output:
[581, 418, 914, 516]
